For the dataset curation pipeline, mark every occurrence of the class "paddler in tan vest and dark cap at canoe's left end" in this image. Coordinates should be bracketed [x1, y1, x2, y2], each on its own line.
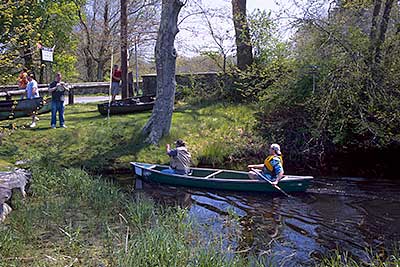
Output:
[161, 139, 192, 175]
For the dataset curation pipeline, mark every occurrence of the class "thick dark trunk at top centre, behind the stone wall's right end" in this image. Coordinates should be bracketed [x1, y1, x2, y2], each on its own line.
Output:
[232, 0, 253, 70]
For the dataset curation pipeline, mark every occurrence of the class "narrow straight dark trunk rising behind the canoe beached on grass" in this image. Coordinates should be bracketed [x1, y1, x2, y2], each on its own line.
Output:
[121, 0, 128, 99]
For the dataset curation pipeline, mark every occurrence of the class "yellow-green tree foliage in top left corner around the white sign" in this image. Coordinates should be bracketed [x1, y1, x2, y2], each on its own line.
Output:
[0, 0, 83, 84]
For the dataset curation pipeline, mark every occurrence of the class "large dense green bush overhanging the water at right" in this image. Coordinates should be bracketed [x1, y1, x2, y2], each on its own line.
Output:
[252, 2, 400, 172]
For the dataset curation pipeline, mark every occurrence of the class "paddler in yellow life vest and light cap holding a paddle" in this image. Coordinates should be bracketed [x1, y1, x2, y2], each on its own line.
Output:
[247, 144, 283, 185]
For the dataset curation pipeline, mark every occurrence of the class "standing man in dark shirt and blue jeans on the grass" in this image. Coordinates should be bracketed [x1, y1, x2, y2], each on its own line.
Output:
[49, 72, 68, 129]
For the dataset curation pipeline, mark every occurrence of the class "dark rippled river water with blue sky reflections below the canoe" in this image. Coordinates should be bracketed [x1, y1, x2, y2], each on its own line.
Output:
[130, 177, 400, 266]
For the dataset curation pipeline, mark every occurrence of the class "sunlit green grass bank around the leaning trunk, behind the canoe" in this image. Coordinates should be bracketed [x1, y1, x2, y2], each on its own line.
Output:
[0, 101, 254, 173]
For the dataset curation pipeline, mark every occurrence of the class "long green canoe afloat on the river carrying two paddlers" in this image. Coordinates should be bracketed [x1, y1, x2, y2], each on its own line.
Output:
[131, 162, 313, 193]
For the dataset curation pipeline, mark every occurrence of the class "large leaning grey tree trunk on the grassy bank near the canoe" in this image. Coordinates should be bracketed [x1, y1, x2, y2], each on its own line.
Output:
[143, 0, 184, 144]
